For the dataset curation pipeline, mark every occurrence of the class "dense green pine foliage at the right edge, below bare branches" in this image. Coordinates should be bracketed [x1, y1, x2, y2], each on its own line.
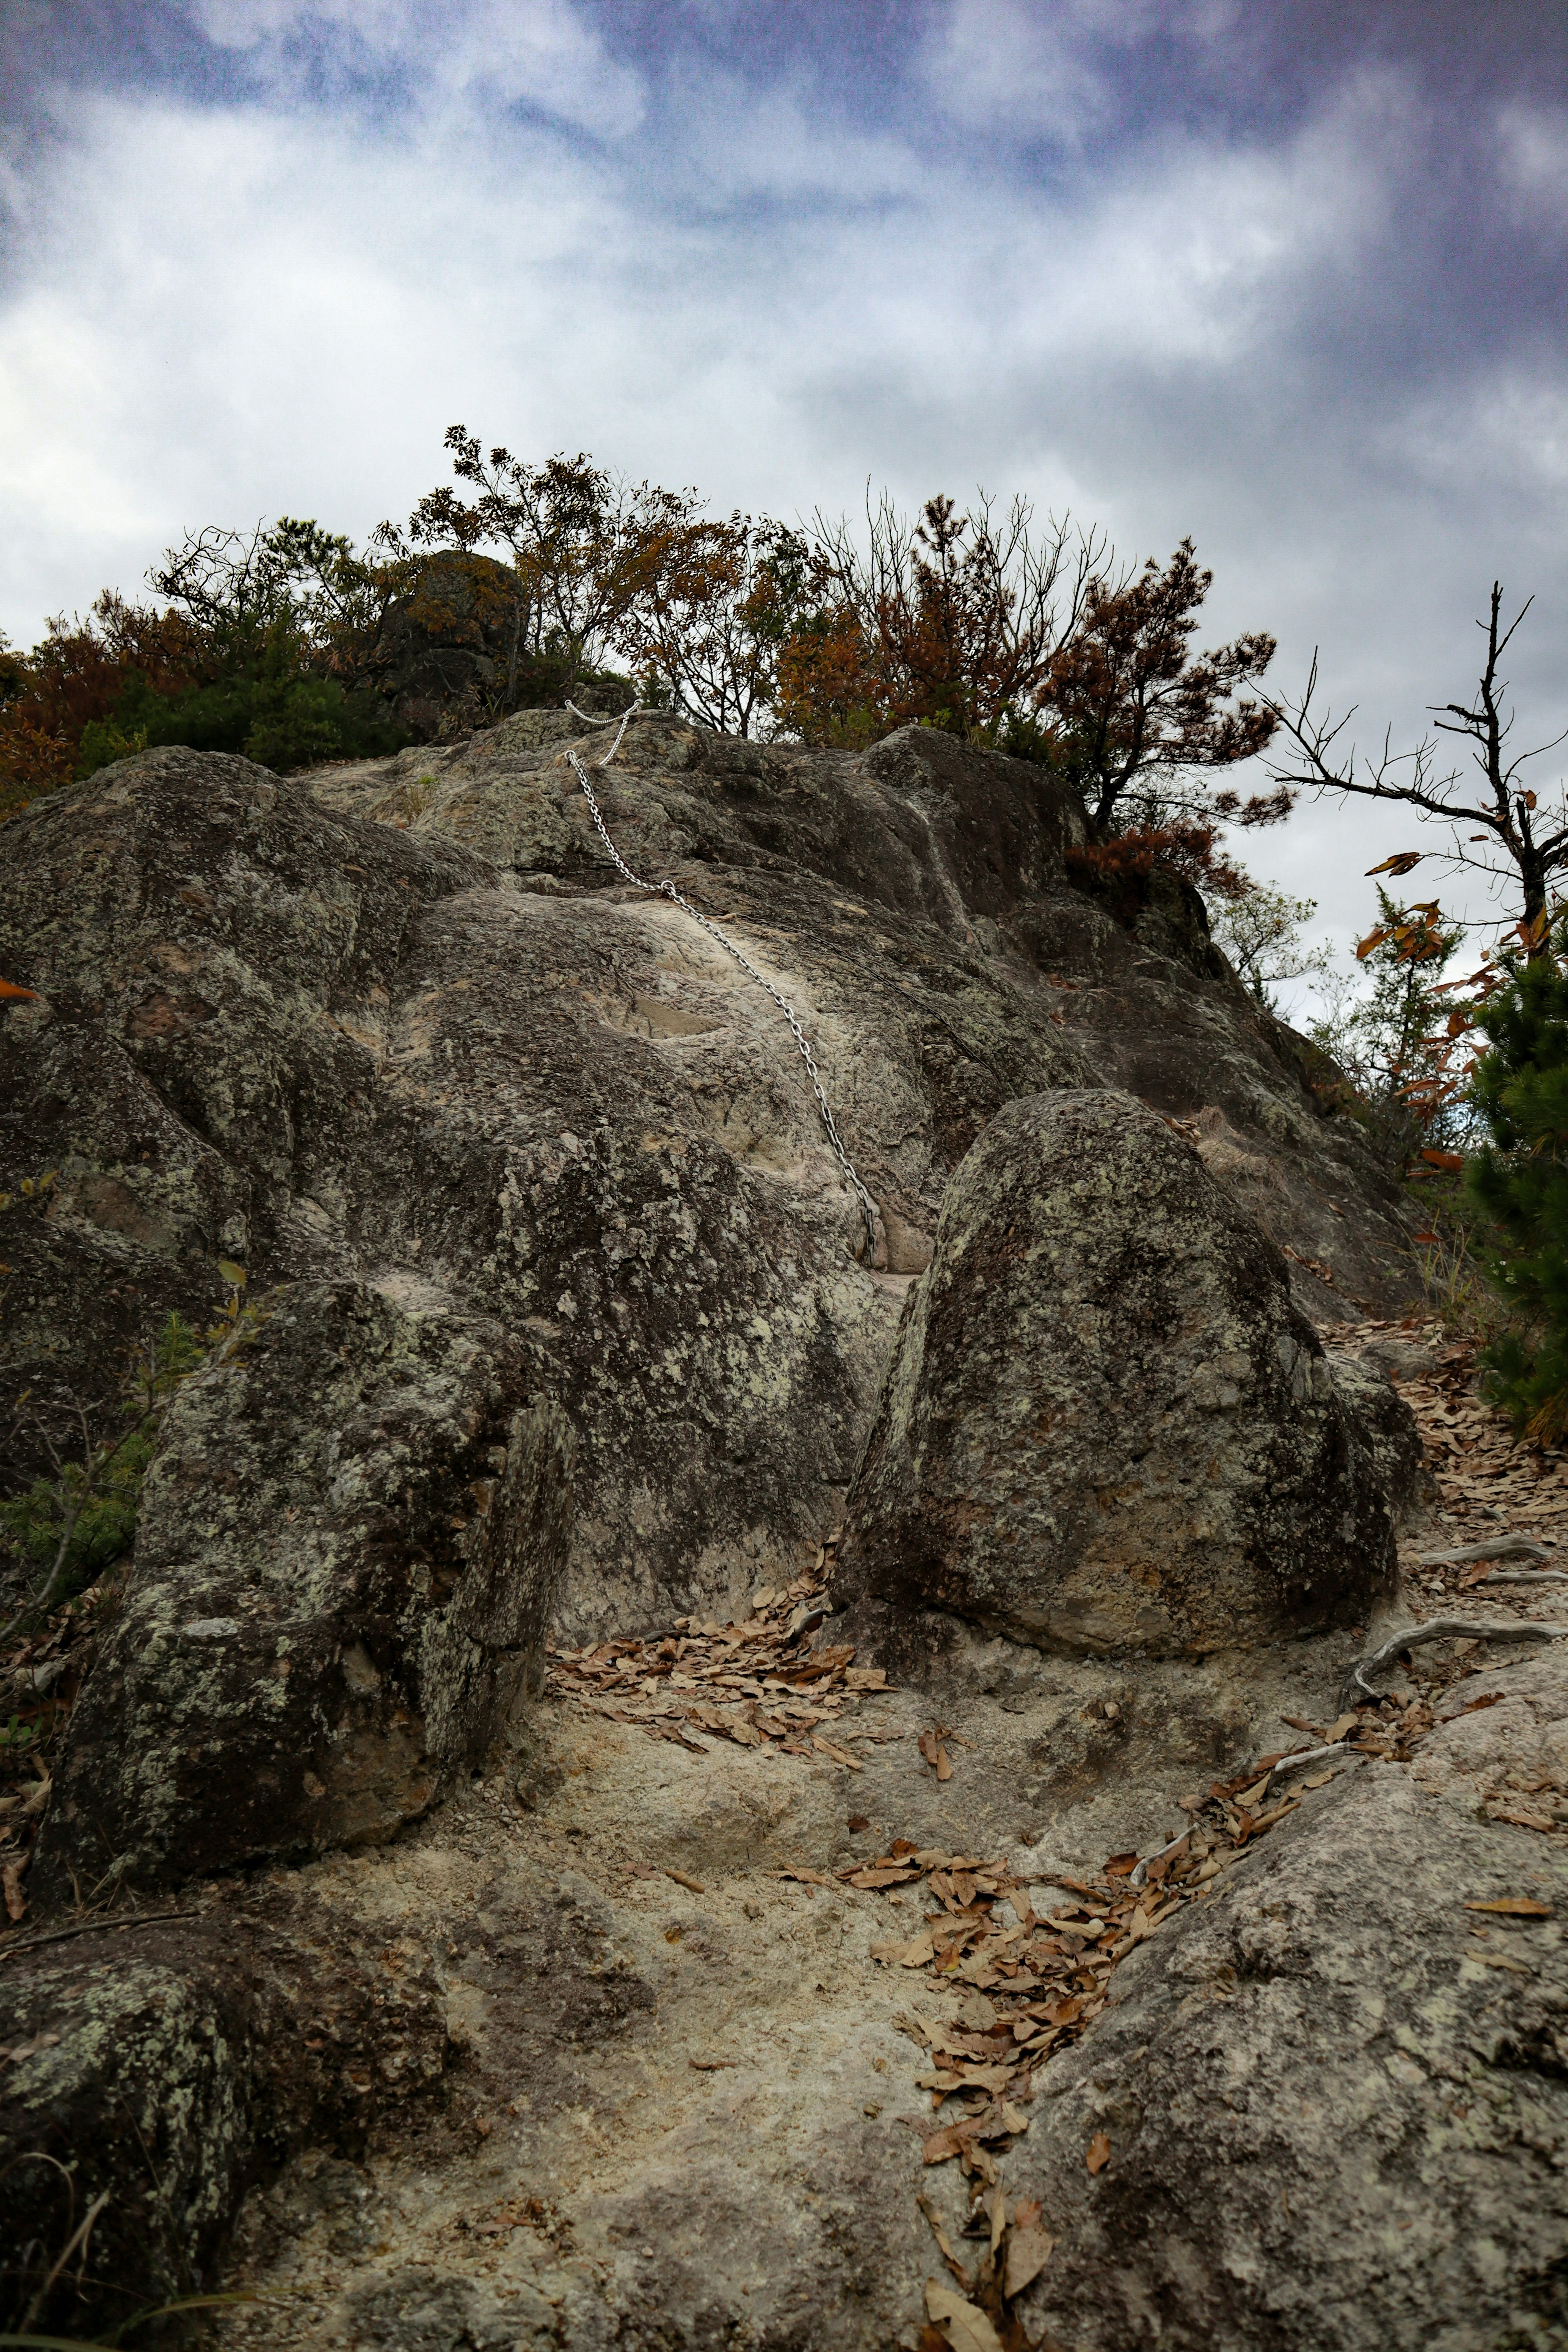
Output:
[1467, 920, 1568, 1444]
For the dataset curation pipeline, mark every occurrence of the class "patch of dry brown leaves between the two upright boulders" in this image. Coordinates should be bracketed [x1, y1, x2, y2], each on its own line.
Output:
[548, 1543, 893, 1778]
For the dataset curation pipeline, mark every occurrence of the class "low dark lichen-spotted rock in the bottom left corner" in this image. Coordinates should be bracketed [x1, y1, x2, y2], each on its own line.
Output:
[0, 1896, 447, 2338]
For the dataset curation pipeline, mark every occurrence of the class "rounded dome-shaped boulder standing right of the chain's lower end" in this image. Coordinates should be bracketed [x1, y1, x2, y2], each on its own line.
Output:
[839, 1091, 1408, 1651]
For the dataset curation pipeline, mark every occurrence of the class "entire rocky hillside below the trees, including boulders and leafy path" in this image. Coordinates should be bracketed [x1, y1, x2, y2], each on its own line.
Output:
[0, 713, 1568, 2352]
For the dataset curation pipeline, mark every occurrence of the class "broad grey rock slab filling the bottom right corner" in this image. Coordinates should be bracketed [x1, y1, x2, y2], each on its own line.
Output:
[1013, 1653, 1568, 2352]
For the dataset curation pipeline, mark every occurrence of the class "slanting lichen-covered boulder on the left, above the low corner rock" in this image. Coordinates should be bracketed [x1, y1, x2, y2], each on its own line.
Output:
[33, 1282, 574, 1900]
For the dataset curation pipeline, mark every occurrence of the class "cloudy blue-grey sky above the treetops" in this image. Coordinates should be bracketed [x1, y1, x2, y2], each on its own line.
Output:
[0, 0, 1568, 983]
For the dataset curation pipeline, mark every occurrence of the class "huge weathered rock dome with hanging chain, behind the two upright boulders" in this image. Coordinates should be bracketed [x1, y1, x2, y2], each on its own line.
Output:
[0, 713, 1403, 1675]
